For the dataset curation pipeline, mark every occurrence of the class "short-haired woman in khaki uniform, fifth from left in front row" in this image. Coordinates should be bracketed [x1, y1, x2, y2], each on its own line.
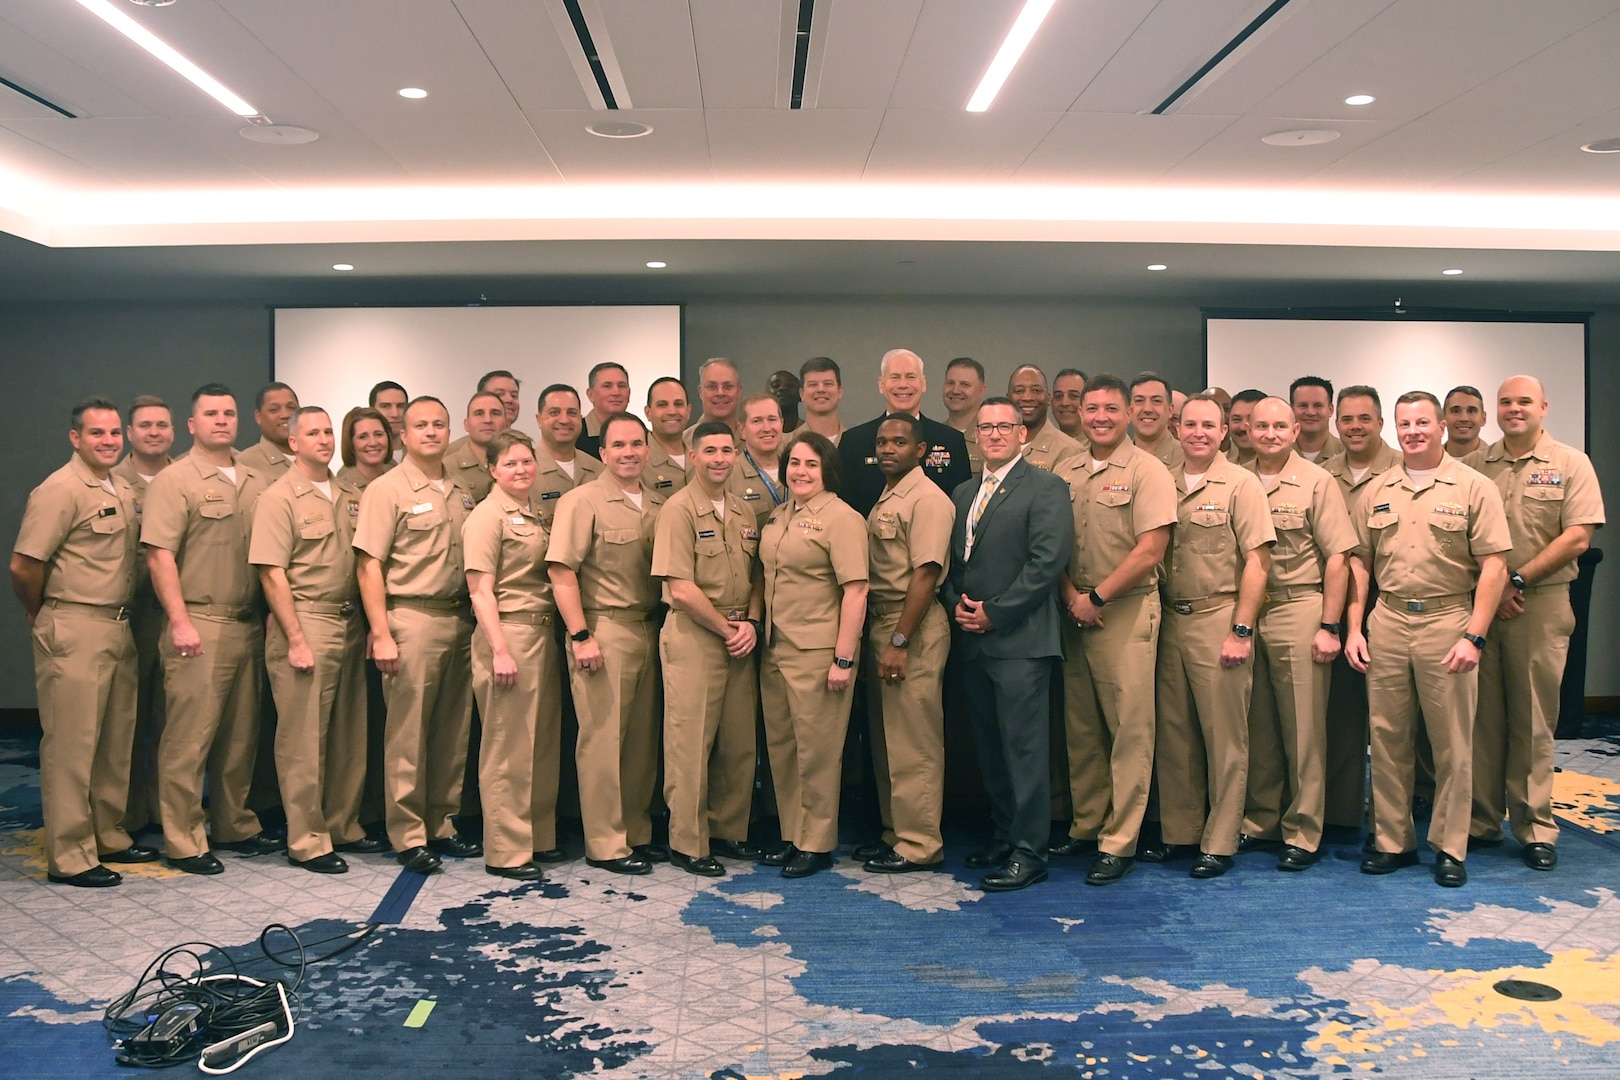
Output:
[462, 431, 562, 881]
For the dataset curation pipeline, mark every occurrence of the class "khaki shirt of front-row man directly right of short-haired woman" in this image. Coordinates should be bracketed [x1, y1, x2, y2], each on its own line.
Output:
[546, 476, 664, 612]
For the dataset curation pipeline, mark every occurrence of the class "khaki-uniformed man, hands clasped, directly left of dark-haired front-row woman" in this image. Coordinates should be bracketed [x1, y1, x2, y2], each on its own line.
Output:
[653, 421, 765, 878]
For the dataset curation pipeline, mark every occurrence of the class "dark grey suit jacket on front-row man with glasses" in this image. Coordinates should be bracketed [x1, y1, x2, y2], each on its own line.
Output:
[940, 458, 1074, 659]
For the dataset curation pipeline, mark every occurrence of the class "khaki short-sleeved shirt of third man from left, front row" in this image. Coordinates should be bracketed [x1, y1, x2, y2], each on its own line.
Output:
[248, 468, 360, 604]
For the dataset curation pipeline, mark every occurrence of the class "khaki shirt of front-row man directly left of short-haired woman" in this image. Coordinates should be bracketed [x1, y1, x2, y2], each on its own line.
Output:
[355, 458, 478, 601]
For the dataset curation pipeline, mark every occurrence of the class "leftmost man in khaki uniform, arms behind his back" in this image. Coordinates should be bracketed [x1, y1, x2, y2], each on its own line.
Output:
[11, 398, 157, 889]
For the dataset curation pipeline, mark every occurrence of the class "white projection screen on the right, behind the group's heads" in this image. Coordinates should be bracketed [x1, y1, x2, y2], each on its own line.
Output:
[1204, 314, 1586, 450]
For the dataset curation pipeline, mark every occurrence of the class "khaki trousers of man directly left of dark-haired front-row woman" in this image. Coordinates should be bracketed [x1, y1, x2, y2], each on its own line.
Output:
[658, 612, 760, 858]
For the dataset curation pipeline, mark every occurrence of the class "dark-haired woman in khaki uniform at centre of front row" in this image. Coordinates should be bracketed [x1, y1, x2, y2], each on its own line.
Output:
[760, 431, 868, 878]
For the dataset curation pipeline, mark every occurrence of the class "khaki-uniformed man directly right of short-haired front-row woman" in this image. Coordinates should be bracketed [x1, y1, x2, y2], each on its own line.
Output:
[546, 413, 667, 874]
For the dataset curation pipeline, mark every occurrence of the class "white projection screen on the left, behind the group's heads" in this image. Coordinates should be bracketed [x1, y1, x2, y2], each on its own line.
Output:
[275, 304, 680, 436]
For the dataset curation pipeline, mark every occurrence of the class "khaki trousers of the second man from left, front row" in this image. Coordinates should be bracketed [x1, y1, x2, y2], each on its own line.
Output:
[157, 614, 264, 858]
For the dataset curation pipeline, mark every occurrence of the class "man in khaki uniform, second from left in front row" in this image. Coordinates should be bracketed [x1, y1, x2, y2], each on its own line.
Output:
[141, 382, 282, 874]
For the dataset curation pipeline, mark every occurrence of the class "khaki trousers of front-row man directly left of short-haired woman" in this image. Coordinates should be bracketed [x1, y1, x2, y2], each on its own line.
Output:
[382, 607, 473, 852]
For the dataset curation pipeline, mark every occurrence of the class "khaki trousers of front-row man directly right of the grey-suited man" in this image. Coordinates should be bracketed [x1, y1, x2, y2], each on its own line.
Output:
[1063, 591, 1163, 858]
